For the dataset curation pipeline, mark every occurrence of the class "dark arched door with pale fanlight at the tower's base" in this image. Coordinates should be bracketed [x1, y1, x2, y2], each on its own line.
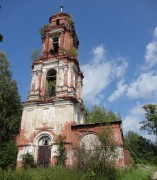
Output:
[37, 136, 52, 166]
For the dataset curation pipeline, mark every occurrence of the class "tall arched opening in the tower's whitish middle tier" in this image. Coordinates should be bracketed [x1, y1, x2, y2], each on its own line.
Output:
[47, 69, 56, 96]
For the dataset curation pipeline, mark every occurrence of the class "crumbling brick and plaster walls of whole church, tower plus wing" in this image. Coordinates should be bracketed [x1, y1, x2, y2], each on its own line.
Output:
[17, 10, 129, 167]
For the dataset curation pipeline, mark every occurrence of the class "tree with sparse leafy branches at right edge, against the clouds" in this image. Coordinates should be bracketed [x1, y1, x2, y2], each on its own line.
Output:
[140, 104, 157, 146]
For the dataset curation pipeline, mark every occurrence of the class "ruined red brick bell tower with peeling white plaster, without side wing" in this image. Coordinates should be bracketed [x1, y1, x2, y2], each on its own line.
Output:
[17, 7, 86, 166]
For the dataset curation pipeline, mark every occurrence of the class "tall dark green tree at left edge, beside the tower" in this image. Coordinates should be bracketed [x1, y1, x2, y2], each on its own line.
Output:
[0, 51, 21, 167]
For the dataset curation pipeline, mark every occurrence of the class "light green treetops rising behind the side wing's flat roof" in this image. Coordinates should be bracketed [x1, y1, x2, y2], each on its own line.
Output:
[86, 105, 121, 123]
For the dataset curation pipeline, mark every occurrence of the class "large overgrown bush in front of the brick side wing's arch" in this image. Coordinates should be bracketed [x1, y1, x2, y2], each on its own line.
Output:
[75, 126, 119, 180]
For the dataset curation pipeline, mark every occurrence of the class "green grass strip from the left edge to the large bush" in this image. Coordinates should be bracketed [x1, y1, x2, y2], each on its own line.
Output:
[0, 167, 103, 180]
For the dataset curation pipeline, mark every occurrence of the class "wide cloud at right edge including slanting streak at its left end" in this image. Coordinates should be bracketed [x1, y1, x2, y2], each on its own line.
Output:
[108, 71, 157, 102]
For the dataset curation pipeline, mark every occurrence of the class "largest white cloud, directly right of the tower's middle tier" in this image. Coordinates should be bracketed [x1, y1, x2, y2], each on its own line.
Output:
[81, 45, 128, 104]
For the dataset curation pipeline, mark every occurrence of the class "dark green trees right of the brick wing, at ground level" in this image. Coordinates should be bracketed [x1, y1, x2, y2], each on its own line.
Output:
[124, 131, 157, 164]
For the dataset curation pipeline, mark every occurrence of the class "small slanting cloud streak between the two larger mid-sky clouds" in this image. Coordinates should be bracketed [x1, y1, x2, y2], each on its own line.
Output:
[108, 81, 127, 102]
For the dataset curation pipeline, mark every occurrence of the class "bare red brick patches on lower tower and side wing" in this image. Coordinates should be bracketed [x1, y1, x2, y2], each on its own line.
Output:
[17, 115, 127, 167]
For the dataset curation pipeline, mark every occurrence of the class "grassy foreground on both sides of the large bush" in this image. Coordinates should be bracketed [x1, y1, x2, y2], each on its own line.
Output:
[0, 166, 157, 180]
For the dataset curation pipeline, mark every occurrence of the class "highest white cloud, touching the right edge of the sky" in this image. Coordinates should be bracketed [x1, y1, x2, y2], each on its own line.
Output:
[142, 27, 157, 70]
